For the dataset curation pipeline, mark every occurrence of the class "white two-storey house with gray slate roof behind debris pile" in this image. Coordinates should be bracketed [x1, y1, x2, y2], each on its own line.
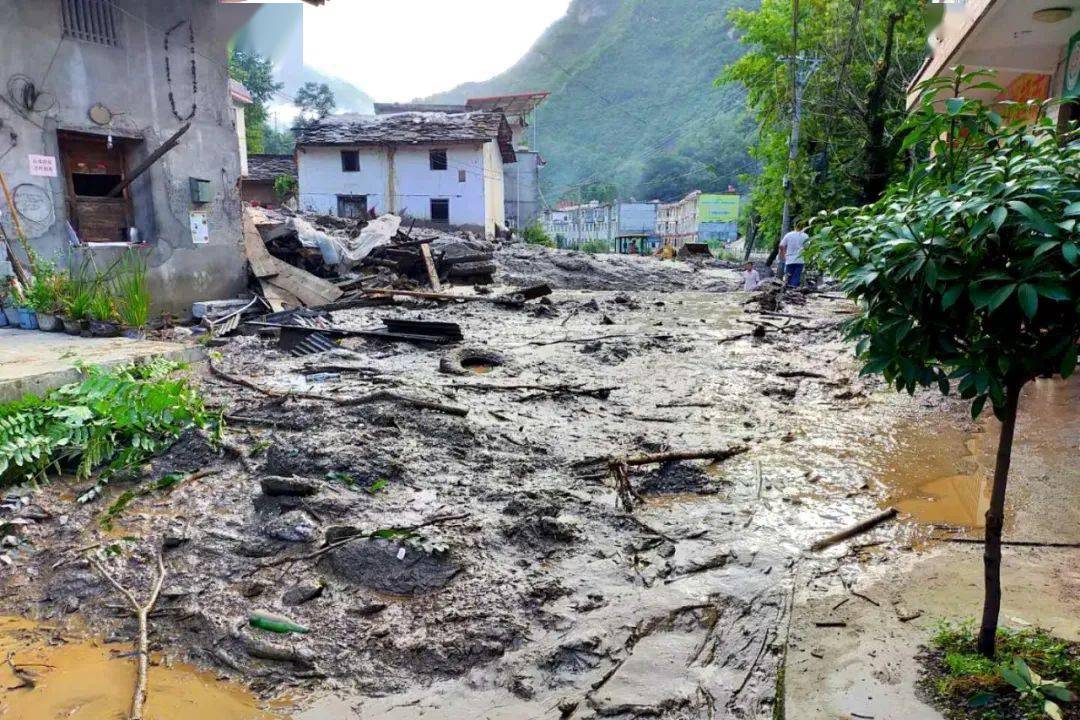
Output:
[296, 111, 516, 235]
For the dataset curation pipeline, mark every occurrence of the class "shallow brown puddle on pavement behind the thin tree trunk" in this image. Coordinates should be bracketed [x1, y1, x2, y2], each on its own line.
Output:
[878, 378, 1080, 530]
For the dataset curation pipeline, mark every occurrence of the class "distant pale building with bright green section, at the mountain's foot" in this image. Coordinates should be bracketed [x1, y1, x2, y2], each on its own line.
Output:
[657, 190, 740, 249]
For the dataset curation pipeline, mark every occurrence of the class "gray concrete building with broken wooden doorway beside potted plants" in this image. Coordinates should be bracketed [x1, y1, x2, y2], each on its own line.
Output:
[0, 0, 267, 314]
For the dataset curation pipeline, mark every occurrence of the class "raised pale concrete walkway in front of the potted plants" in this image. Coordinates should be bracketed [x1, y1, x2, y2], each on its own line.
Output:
[0, 327, 203, 403]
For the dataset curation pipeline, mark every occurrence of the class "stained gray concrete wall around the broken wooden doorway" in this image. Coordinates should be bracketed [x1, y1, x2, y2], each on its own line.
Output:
[0, 0, 246, 315]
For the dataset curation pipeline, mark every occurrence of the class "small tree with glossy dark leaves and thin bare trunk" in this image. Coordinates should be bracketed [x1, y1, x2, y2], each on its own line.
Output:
[811, 68, 1080, 656]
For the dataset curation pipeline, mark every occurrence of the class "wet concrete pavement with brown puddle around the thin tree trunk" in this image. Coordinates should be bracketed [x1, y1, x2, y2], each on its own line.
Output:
[785, 379, 1080, 720]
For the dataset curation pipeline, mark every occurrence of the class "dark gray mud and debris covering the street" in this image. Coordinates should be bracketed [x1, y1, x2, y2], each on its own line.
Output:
[0, 248, 1071, 720]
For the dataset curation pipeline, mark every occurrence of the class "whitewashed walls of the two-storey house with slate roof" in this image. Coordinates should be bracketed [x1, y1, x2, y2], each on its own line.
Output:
[297, 142, 494, 232]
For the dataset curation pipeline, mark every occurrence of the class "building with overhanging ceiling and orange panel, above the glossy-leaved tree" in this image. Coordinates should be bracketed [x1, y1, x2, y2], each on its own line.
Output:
[907, 0, 1080, 122]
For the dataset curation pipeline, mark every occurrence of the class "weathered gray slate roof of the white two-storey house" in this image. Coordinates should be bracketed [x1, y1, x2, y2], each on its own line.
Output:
[296, 111, 515, 163]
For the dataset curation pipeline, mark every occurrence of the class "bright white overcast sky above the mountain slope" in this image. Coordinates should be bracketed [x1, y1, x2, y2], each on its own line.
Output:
[303, 0, 570, 101]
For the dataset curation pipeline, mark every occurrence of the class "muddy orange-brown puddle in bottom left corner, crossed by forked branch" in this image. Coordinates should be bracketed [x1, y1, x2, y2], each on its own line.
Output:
[0, 617, 285, 720]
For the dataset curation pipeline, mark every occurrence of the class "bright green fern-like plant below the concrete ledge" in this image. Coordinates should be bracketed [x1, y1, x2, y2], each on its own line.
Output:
[0, 359, 216, 502]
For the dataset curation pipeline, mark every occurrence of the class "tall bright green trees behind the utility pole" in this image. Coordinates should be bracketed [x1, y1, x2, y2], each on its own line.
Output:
[716, 0, 926, 254]
